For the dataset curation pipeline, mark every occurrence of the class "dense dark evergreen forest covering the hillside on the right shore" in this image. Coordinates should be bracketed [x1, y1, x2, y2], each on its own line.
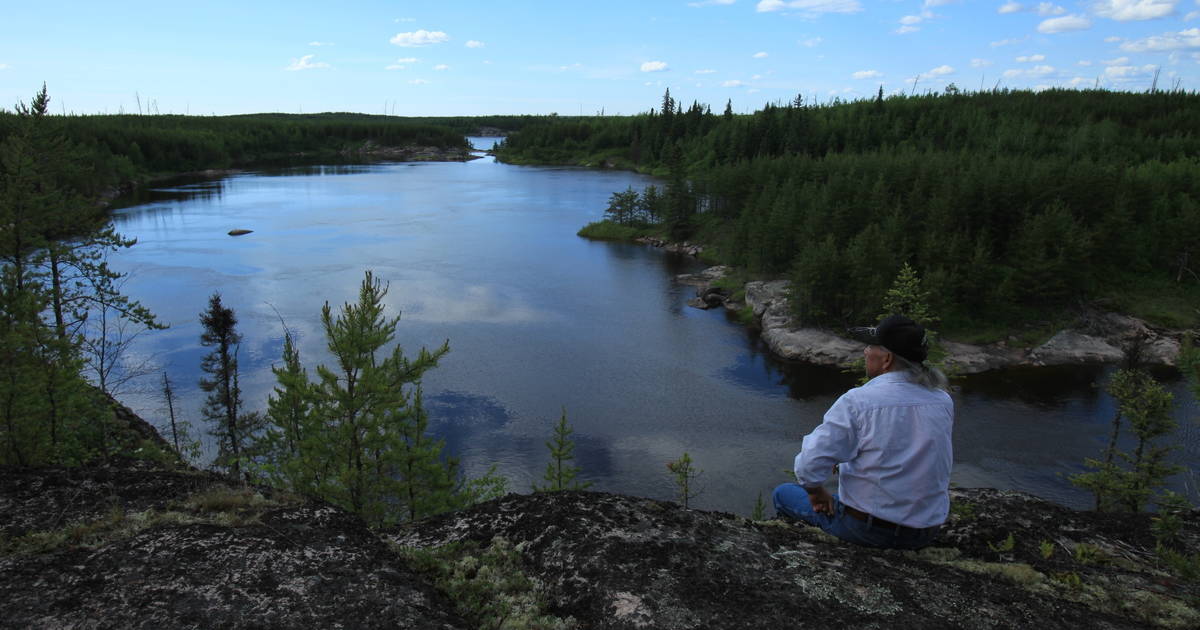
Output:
[499, 89, 1200, 340]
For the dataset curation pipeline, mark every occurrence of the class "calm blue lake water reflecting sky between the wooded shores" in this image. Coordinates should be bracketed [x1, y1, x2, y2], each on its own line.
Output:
[105, 139, 1200, 514]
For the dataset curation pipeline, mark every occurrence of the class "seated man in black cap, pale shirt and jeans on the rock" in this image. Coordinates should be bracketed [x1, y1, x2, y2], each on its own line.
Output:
[774, 316, 954, 548]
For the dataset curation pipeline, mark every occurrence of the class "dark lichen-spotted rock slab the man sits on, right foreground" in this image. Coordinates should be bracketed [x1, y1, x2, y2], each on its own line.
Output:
[389, 491, 1200, 629]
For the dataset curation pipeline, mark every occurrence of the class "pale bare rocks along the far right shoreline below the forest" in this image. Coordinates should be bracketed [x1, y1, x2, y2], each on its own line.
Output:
[679, 266, 1180, 374]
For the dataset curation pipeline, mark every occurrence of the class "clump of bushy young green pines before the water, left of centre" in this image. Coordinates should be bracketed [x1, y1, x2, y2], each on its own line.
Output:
[264, 271, 458, 526]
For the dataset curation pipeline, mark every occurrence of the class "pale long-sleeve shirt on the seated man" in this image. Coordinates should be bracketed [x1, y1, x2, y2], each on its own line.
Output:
[796, 372, 954, 528]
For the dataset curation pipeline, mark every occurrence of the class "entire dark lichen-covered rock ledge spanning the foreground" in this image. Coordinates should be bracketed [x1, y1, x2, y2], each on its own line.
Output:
[0, 463, 1200, 629]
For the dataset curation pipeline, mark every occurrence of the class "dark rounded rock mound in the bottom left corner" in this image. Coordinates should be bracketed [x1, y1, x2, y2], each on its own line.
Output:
[0, 456, 468, 629]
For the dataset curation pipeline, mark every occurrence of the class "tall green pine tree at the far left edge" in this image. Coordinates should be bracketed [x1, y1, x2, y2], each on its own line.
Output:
[0, 85, 110, 464]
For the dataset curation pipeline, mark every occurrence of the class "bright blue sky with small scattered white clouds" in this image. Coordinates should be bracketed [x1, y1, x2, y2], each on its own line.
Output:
[0, 0, 1200, 116]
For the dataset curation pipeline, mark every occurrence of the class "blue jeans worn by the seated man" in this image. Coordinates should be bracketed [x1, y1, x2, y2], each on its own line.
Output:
[773, 484, 940, 550]
